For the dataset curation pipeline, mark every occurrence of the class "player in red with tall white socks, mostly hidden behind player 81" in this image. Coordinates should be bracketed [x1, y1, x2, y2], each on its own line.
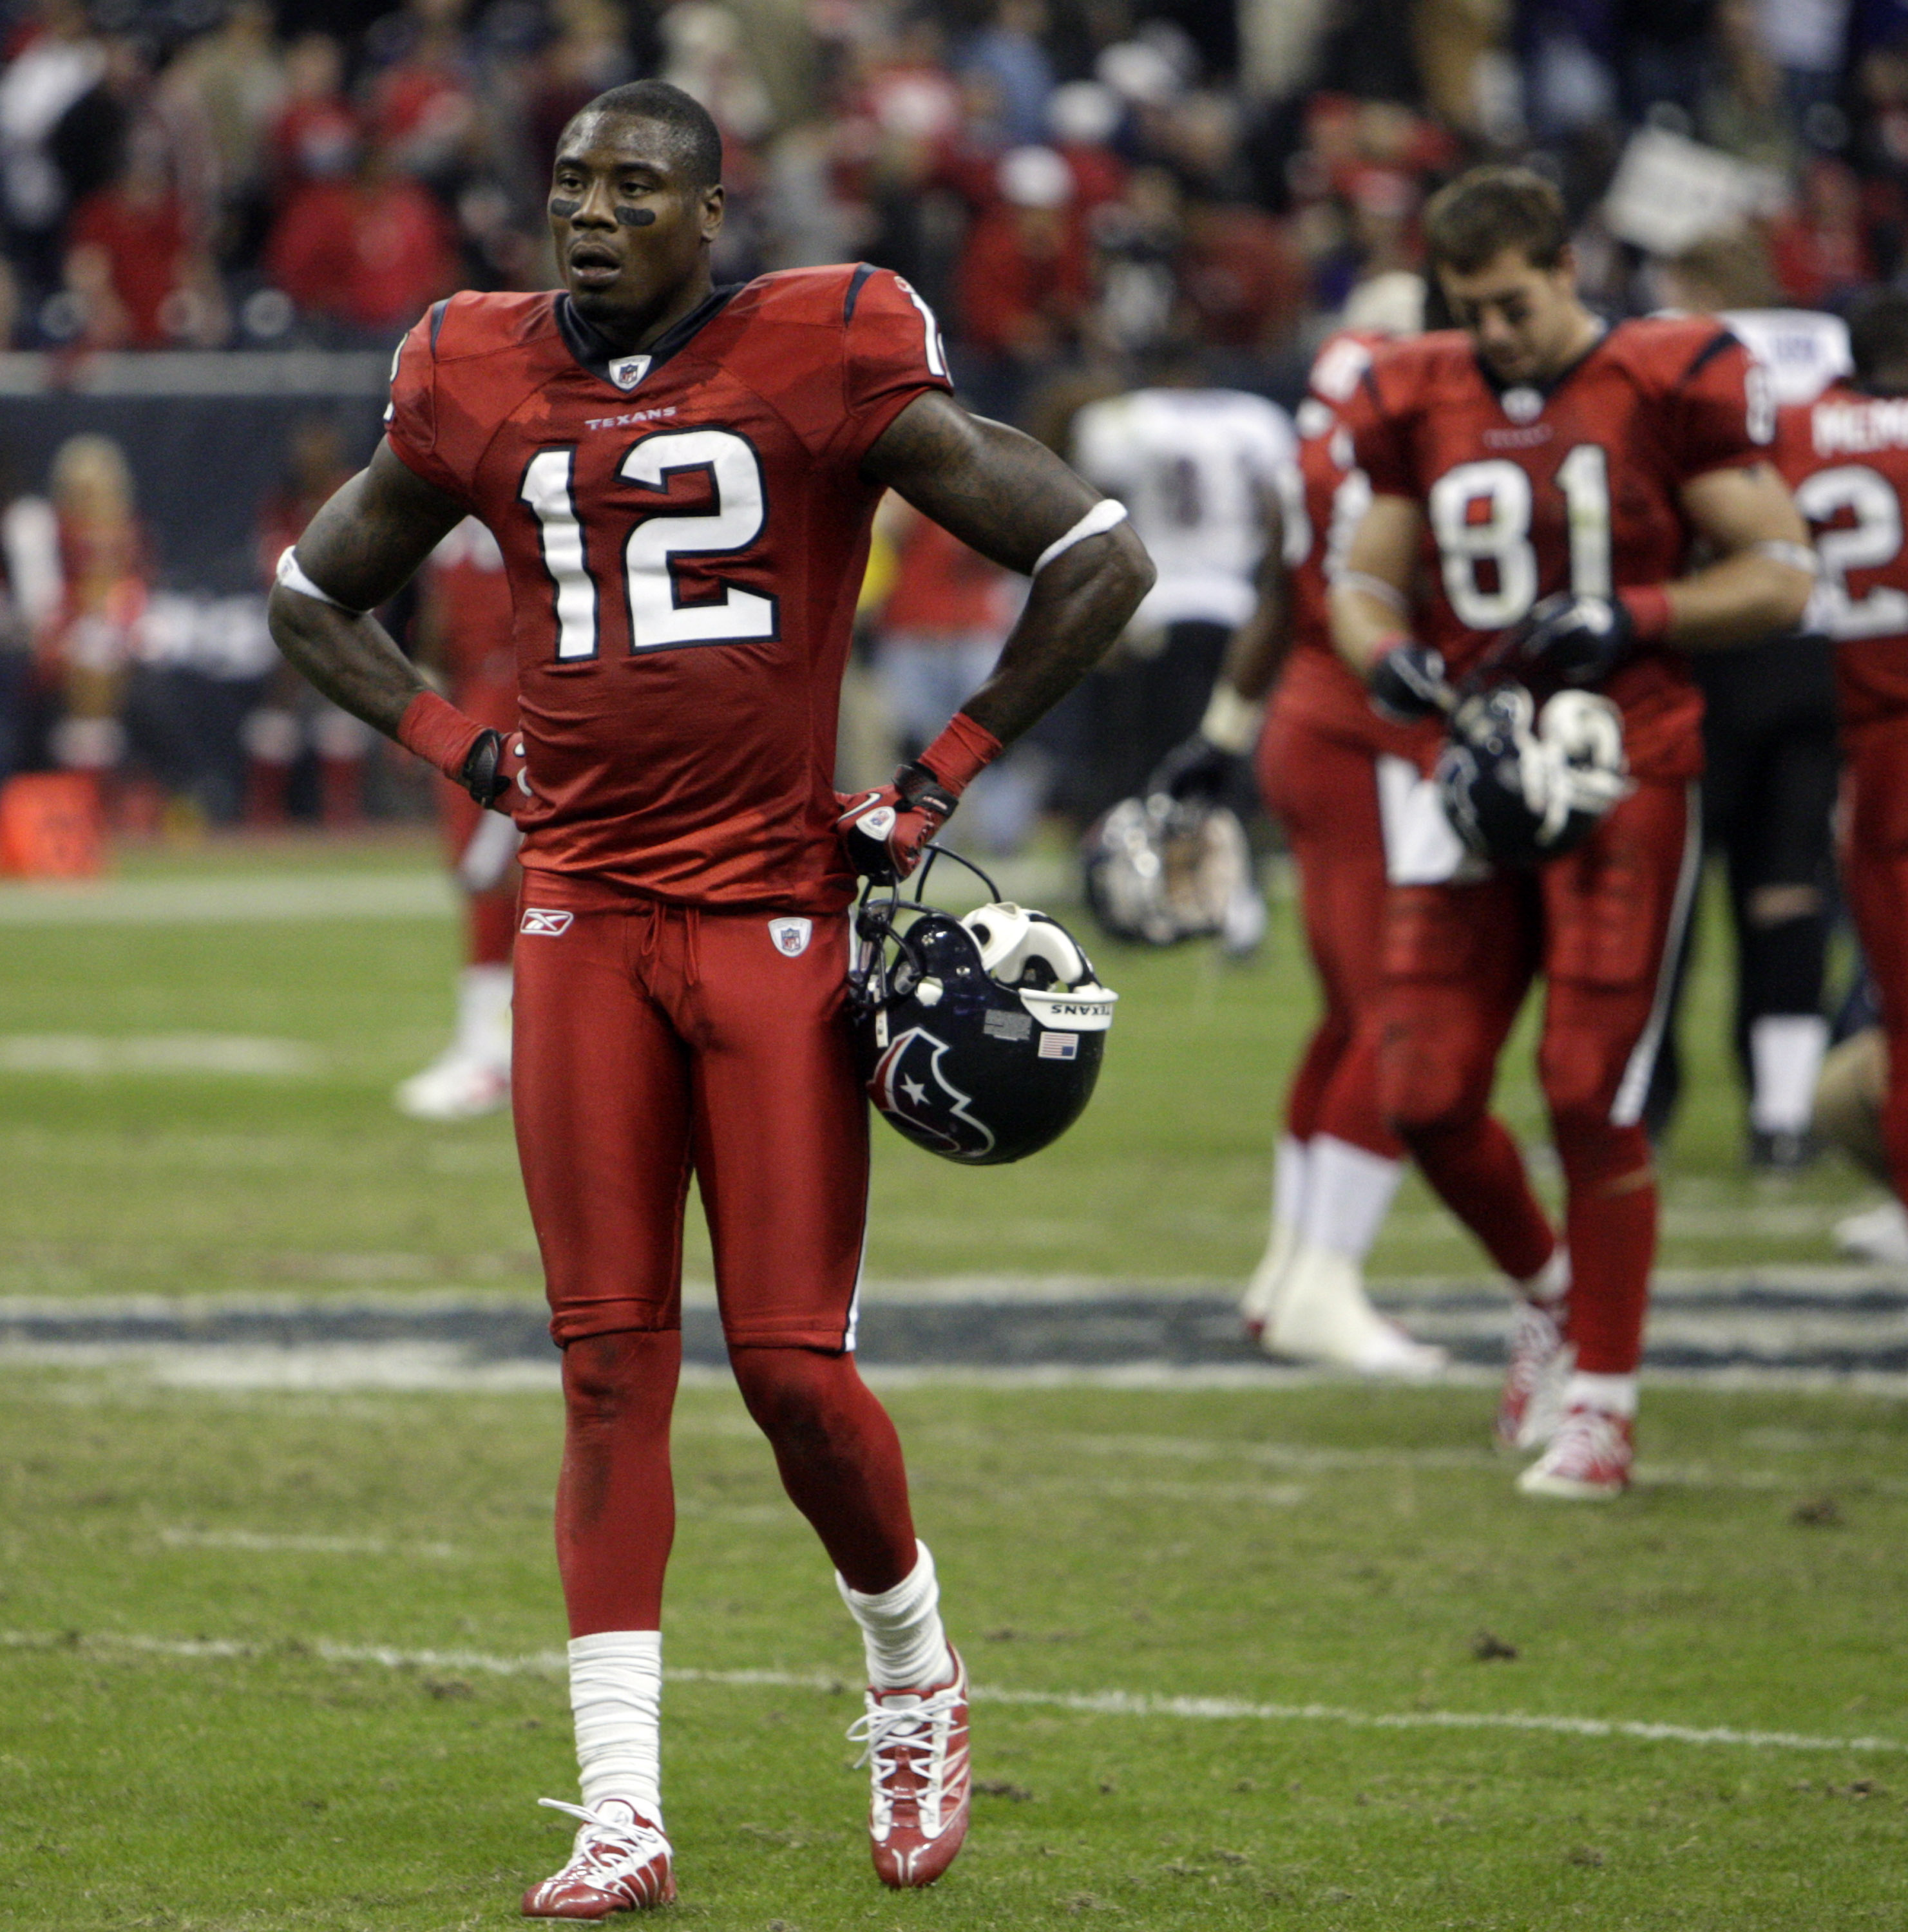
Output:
[1154, 286, 1444, 1376]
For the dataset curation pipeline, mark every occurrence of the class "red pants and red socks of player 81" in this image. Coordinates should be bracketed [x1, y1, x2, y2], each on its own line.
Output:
[1379, 781, 1701, 1376]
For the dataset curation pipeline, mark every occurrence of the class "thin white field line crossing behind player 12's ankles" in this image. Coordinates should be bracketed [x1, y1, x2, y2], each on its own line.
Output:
[0, 1631, 1908, 1752]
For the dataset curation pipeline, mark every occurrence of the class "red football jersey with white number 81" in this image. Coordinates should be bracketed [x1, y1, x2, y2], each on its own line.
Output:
[1357, 317, 1775, 779]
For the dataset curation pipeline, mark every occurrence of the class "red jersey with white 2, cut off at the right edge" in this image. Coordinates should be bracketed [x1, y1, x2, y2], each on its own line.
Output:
[1777, 383, 1908, 730]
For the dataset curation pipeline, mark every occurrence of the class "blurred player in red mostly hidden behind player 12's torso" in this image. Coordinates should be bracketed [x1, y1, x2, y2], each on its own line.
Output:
[394, 516, 518, 1121]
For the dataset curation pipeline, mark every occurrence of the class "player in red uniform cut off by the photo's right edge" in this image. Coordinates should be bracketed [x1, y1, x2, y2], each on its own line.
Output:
[1777, 290, 1908, 1236]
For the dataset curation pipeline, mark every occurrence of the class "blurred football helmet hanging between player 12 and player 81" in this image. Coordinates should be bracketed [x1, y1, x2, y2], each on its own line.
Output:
[1081, 792, 1253, 947]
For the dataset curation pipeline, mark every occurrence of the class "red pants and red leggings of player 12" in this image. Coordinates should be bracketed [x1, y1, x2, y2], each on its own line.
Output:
[512, 873, 914, 1636]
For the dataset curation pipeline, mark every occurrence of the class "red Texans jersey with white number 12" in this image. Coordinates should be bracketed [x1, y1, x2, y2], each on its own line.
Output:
[388, 265, 949, 912]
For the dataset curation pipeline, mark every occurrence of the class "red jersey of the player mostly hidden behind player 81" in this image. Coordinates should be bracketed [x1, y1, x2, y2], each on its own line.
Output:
[1274, 332, 1444, 761]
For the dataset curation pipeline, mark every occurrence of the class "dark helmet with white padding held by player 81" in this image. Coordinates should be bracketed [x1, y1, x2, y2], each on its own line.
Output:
[1436, 684, 1630, 866]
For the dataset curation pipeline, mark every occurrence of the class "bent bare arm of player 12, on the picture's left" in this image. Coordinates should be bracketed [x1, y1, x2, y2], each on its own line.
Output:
[269, 444, 464, 736]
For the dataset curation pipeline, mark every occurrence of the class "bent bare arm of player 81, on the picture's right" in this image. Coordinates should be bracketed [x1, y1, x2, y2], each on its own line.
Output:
[1666, 466, 1815, 651]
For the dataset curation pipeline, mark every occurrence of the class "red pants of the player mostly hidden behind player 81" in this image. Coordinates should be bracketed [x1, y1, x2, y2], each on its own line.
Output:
[1259, 703, 1404, 1159]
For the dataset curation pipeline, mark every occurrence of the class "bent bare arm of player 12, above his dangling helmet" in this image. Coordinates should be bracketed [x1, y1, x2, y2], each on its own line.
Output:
[864, 390, 1154, 744]
